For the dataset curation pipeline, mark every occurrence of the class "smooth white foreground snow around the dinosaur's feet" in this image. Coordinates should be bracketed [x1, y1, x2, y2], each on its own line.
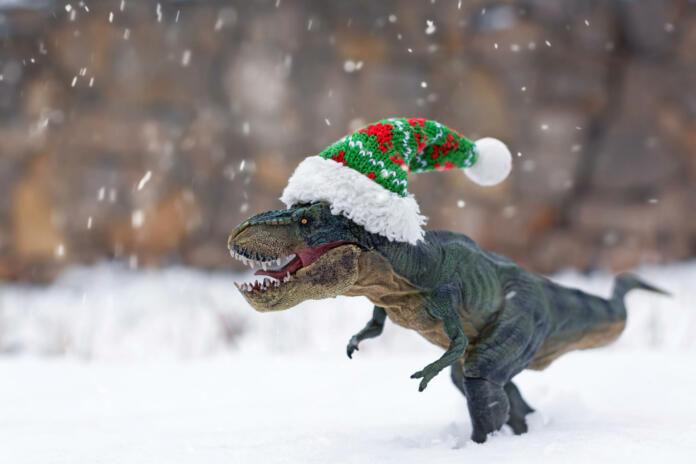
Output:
[0, 350, 696, 464]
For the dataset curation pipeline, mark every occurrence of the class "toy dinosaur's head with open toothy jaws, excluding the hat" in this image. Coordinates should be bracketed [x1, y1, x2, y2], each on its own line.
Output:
[227, 202, 361, 312]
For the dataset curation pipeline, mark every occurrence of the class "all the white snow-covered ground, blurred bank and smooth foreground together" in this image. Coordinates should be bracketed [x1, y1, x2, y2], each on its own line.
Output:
[0, 263, 696, 464]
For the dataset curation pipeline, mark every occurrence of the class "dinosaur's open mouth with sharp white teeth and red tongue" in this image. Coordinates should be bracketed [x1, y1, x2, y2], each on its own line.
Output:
[230, 240, 352, 294]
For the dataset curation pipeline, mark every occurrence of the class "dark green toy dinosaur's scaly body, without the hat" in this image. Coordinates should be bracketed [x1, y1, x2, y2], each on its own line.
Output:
[228, 203, 660, 443]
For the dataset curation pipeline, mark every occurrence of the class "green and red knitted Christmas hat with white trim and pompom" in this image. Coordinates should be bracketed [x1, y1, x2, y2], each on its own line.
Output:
[280, 118, 512, 244]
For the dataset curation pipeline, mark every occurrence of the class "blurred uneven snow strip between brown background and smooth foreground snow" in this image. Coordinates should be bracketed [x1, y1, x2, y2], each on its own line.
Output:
[0, 258, 696, 360]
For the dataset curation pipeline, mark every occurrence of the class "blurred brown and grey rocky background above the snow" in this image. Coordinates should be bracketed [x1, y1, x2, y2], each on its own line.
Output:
[0, 0, 696, 282]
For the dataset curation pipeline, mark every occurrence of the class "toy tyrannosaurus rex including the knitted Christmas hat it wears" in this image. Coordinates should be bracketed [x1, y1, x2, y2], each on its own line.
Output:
[228, 118, 659, 442]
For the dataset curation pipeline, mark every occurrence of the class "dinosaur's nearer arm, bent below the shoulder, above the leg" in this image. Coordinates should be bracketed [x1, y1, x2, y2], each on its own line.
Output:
[411, 284, 469, 391]
